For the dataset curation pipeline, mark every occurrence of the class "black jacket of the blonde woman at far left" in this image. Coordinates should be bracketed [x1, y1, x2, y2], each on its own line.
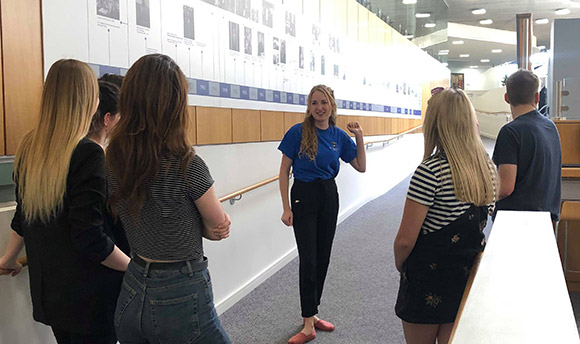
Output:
[12, 138, 123, 334]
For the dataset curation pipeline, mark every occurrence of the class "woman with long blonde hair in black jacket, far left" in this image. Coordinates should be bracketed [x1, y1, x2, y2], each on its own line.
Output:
[0, 60, 129, 344]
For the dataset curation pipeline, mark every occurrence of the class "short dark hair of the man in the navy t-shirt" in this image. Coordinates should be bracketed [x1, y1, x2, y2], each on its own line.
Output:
[505, 69, 540, 106]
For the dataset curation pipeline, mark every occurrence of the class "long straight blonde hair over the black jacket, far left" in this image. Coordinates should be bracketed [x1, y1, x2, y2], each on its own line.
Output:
[14, 59, 99, 223]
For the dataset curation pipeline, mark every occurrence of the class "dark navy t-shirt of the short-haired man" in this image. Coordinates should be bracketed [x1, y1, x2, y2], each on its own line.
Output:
[493, 110, 562, 221]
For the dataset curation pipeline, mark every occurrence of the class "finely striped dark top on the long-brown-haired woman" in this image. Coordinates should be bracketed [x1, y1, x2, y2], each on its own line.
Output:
[107, 155, 214, 260]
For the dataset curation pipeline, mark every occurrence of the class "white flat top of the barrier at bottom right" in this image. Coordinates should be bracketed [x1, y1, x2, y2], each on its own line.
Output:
[450, 211, 580, 344]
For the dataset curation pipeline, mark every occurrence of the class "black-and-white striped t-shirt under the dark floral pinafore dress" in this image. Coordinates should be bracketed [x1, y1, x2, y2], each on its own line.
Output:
[407, 155, 471, 234]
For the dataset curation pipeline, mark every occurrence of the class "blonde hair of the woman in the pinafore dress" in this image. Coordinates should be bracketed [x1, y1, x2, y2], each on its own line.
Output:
[423, 88, 498, 206]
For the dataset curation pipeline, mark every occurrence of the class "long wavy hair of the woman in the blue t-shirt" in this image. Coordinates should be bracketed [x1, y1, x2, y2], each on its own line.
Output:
[299, 85, 336, 161]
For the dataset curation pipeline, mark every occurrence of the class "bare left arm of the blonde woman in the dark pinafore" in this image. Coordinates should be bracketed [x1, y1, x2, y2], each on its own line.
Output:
[394, 199, 429, 271]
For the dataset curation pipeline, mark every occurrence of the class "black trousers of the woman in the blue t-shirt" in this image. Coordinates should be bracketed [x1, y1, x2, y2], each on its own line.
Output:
[290, 179, 338, 318]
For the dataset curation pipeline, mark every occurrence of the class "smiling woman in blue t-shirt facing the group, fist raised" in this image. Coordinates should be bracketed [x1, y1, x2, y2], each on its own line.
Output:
[278, 85, 366, 344]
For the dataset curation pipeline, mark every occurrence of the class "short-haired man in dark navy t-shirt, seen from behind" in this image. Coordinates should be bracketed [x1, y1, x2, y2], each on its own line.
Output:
[493, 69, 562, 221]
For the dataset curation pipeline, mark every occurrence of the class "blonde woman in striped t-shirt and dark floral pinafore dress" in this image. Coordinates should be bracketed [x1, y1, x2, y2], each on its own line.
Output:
[394, 88, 497, 343]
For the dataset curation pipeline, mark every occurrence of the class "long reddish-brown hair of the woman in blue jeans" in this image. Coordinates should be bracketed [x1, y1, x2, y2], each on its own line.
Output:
[106, 54, 194, 216]
